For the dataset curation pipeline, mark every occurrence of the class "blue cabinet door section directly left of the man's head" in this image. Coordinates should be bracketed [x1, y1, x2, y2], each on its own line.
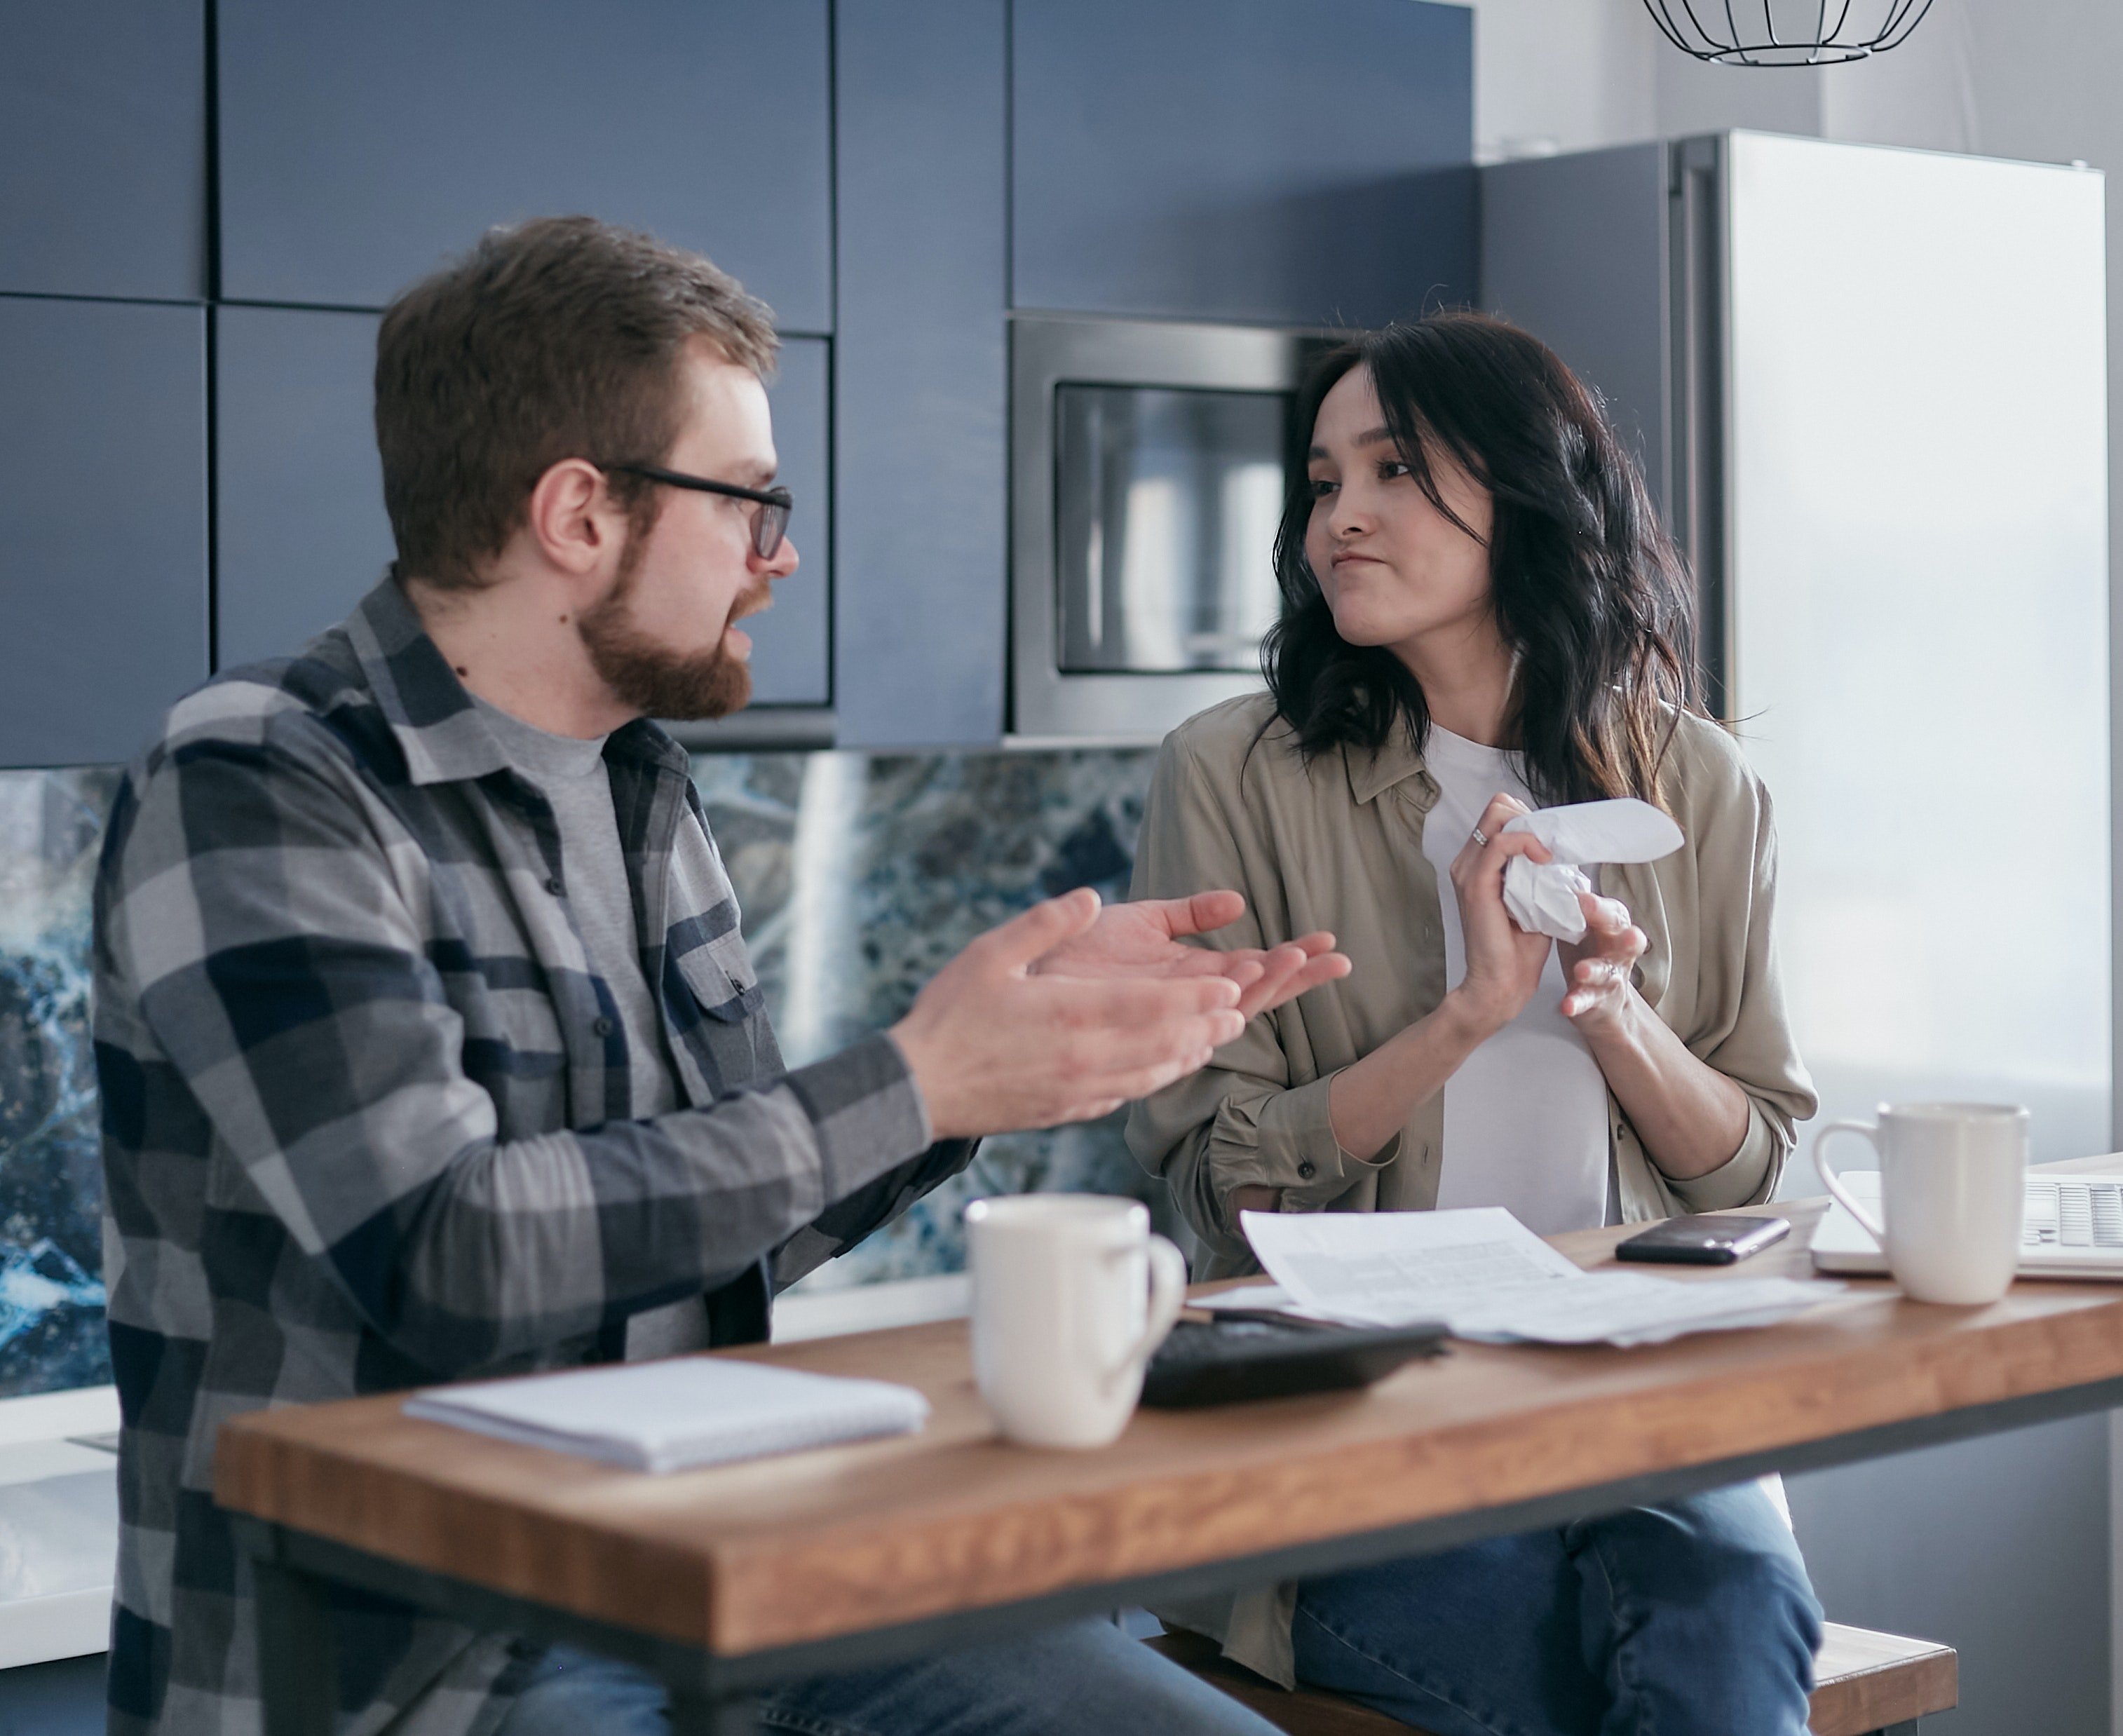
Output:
[215, 308, 391, 668]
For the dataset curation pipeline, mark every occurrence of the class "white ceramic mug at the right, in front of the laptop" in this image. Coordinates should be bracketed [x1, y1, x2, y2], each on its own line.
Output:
[1813, 1104, 2028, 1303]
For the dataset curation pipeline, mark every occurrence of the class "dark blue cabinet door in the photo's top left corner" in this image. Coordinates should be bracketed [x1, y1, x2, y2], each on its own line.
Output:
[0, 0, 206, 301]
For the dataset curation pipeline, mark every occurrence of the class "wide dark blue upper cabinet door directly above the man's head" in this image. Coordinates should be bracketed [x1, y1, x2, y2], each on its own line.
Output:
[219, 0, 832, 331]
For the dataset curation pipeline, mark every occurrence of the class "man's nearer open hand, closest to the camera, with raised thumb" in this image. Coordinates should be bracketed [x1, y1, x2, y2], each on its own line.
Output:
[892, 889, 1246, 1139]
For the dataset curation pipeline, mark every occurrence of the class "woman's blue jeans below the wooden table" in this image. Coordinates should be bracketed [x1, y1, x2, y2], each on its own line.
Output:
[1295, 1484, 1822, 1736]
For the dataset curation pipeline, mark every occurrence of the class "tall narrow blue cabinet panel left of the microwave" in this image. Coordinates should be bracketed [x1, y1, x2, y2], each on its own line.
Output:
[834, 0, 1008, 747]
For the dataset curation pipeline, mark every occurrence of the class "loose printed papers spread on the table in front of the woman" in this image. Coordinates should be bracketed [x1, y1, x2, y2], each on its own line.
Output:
[1219, 1205, 1843, 1345]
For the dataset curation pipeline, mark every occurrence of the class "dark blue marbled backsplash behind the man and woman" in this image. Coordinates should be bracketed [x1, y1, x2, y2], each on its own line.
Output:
[0, 752, 1172, 1397]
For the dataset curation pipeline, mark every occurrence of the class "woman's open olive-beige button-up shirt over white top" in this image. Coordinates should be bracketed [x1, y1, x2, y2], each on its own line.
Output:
[1127, 694, 1817, 1685]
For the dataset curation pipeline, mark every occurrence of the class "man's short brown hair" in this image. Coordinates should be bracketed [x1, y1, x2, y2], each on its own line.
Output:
[376, 217, 777, 588]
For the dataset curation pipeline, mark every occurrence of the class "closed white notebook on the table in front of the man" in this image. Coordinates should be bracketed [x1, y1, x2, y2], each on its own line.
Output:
[405, 1356, 930, 1471]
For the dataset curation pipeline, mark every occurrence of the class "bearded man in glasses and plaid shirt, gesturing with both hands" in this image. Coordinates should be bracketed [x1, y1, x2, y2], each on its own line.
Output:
[95, 219, 1346, 1736]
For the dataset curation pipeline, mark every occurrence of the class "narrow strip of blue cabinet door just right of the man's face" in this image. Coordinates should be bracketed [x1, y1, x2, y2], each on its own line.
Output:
[745, 337, 832, 705]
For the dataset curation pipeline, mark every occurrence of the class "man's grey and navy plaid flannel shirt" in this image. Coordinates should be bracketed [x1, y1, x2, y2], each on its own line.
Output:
[95, 579, 970, 1736]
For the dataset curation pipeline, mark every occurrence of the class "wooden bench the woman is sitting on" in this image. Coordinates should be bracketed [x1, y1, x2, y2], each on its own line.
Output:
[1144, 1622, 1960, 1736]
